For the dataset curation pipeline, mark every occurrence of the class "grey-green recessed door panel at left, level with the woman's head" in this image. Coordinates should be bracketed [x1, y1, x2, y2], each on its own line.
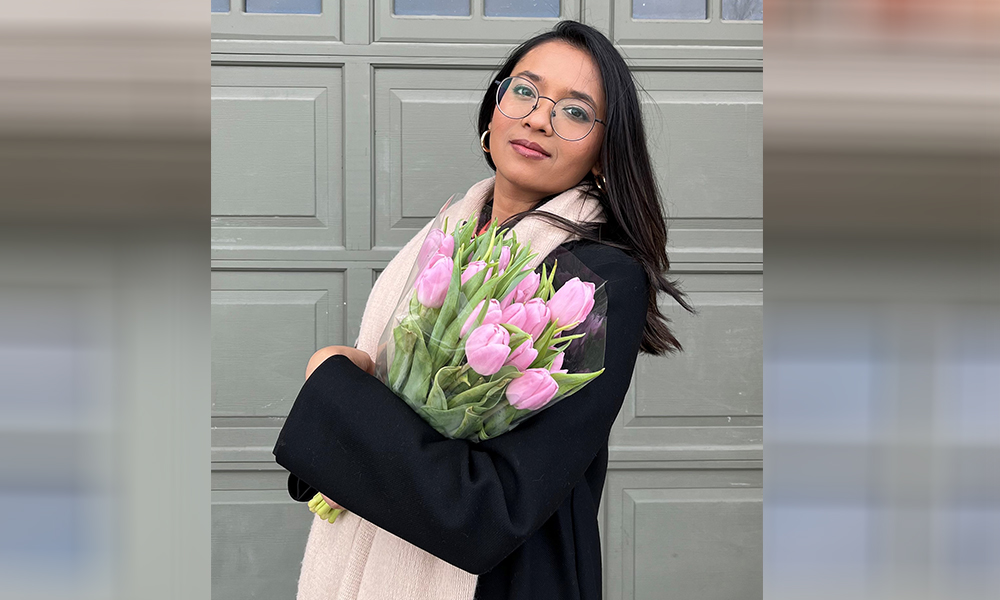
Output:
[212, 66, 344, 251]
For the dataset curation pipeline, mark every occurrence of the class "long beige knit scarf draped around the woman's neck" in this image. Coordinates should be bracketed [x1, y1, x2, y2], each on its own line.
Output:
[296, 177, 605, 600]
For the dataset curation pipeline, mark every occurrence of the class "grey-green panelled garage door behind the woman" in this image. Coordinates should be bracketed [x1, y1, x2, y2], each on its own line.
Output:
[212, 0, 763, 600]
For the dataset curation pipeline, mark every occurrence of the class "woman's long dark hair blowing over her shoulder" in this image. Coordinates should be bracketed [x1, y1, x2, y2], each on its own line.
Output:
[478, 21, 695, 355]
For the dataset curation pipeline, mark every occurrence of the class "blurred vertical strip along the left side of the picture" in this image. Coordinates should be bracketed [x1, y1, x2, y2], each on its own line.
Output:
[0, 0, 211, 600]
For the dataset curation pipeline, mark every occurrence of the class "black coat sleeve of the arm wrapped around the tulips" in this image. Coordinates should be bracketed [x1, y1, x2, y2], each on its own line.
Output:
[274, 246, 648, 574]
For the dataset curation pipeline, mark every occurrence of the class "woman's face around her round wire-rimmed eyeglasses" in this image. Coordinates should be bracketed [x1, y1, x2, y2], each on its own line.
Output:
[488, 41, 607, 198]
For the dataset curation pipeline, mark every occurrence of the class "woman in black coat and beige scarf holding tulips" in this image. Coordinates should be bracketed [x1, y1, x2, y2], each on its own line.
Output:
[274, 21, 693, 600]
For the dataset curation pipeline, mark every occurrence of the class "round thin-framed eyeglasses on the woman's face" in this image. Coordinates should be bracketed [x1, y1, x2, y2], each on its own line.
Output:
[494, 77, 607, 142]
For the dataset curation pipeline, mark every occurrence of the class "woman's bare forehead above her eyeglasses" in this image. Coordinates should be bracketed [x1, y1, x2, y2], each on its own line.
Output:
[511, 42, 604, 103]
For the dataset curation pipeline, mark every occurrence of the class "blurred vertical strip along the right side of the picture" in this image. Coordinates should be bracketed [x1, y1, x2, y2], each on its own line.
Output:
[764, 0, 1000, 599]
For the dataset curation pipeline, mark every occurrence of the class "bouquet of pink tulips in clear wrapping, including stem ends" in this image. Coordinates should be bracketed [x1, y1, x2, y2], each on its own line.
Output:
[309, 199, 607, 523]
